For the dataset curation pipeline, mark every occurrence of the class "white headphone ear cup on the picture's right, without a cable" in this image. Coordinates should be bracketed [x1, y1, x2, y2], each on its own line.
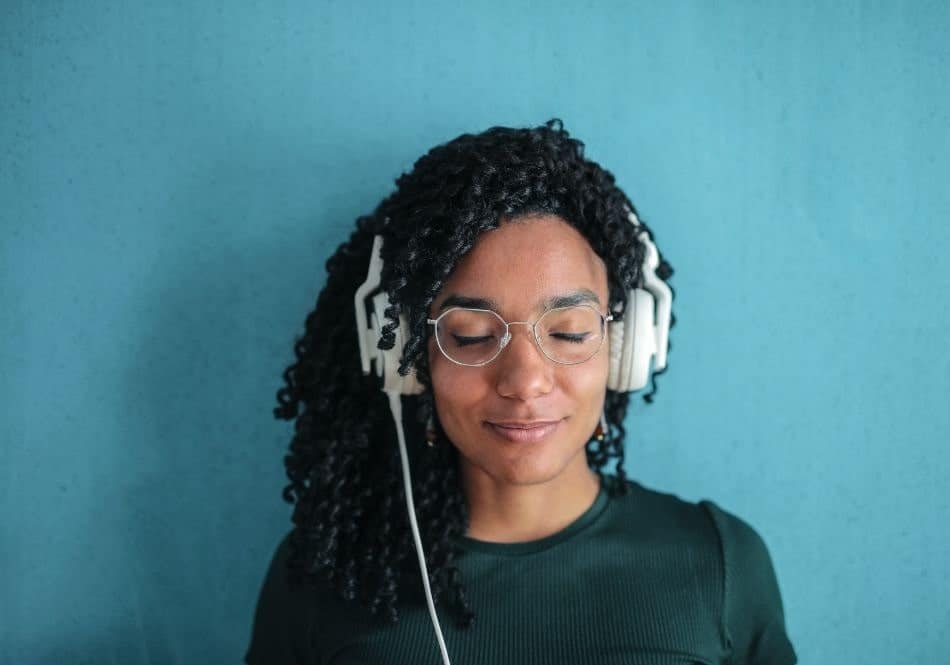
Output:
[607, 289, 656, 392]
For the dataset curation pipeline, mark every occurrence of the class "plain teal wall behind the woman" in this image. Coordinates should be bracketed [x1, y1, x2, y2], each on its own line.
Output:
[0, 0, 950, 665]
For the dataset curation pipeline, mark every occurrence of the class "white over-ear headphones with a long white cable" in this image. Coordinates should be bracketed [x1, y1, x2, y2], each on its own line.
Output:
[353, 210, 673, 665]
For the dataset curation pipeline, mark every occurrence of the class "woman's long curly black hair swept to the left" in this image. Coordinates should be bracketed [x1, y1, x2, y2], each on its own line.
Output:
[274, 120, 675, 627]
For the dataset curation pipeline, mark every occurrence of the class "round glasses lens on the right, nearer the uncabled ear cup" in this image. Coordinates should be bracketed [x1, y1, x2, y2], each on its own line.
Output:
[536, 306, 604, 365]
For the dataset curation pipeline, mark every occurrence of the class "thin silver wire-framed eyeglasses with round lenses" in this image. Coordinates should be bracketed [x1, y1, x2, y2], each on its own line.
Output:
[427, 305, 613, 367]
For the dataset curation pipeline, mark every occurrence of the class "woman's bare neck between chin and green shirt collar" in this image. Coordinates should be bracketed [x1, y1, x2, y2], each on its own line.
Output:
[462, 460, 600, 543]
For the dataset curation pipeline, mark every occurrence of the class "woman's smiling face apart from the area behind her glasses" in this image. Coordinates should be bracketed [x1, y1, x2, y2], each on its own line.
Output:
[428, 215, 609, 485]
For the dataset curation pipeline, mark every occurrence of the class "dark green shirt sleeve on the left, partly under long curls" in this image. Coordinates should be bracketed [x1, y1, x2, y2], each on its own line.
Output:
[244, 534, 316, 665]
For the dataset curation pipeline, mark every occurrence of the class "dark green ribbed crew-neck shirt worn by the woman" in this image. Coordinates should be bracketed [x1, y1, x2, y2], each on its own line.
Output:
[245, 482, 796, 665]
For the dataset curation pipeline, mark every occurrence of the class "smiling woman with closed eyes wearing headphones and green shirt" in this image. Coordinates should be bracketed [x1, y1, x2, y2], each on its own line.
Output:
[246, 121, 795, 665]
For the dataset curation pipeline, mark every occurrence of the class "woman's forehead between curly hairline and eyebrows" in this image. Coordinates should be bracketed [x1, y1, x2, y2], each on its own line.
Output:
[433, 215, 607, 316]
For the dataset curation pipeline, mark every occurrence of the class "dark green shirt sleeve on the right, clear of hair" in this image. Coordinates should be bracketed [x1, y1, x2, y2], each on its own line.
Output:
[703, 501, 798, 665]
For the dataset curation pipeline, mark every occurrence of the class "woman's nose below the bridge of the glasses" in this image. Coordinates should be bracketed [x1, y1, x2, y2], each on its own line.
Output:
[493, 325, 554, 400]
